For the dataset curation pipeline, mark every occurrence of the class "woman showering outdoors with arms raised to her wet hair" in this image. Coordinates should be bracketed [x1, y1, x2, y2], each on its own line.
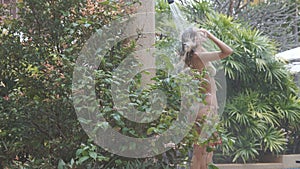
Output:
[182, 28, 233, 169]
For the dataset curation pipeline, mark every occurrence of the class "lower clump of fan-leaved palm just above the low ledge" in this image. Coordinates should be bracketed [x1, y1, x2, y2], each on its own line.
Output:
[222, 91, 287, 162]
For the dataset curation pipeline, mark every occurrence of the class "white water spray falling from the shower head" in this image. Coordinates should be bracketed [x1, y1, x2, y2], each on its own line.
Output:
[170, 3, 191, 34]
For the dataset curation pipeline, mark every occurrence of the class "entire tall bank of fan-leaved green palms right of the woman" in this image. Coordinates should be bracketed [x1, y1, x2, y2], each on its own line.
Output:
[182, 2, 299, 162]
